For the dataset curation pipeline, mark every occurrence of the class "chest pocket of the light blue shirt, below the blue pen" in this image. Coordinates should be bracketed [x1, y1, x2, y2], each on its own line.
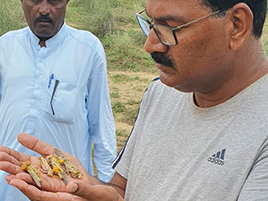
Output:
[45, 79, 78, 124]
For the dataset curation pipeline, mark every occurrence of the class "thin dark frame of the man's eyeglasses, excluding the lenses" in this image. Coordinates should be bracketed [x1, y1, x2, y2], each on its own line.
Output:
[136, 6, 233, 46]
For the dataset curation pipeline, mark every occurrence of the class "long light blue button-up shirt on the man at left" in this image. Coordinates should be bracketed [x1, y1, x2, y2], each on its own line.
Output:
[0, 24, 116, 201]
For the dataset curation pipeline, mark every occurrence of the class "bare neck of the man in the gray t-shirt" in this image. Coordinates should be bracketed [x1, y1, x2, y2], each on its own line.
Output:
[194, 40, 268, 108]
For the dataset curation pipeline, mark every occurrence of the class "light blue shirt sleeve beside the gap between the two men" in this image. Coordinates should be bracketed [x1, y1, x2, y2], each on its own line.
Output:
[87, 48, 117, 183]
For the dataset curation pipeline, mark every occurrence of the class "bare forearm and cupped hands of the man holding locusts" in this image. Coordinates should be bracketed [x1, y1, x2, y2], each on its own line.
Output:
[0, 133, 126, 201]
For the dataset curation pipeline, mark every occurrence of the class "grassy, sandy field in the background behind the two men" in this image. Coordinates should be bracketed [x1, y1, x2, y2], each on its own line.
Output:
[0, 0, 268, 157]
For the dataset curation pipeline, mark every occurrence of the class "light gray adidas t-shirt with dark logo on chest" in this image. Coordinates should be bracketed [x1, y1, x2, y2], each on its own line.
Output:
[113, 76, 268, 201]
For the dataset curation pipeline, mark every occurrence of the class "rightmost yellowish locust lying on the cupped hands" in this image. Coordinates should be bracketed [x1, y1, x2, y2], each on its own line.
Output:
[54, 148, 83, 179]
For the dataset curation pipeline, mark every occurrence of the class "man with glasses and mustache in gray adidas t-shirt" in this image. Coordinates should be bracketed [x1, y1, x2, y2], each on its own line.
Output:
[0, 0, 268, 201]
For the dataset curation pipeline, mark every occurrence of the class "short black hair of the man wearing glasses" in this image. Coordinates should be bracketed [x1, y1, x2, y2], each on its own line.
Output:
[202, 0, 267, 38]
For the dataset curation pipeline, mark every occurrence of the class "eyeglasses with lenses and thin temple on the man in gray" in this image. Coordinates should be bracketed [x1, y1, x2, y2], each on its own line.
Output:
[136, 6, 231, 46]
